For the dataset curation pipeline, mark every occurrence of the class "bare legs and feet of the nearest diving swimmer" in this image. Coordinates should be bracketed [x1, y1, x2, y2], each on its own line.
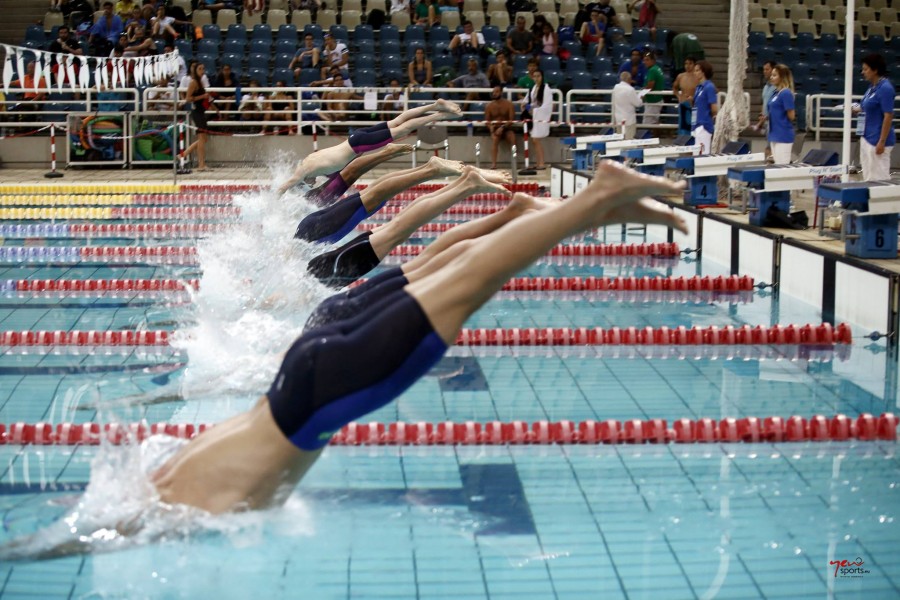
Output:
[405, 163, 686, 345]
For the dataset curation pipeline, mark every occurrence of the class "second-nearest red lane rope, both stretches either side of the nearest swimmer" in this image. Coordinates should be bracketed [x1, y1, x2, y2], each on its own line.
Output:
[0, 324, 853, 346]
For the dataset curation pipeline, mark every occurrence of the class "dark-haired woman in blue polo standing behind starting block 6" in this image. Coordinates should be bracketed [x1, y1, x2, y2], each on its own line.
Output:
[859, 54, 897, 181]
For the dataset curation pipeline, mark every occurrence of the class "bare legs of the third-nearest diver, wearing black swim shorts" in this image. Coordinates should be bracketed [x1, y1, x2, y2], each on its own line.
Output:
[369, 167, 509, 260]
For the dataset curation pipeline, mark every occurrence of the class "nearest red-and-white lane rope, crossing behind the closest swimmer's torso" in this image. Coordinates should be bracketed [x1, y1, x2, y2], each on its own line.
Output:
[0, 413, 900, 446]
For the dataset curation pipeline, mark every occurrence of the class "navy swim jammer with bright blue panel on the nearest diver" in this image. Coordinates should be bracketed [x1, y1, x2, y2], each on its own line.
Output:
[268, 290, 447, 451]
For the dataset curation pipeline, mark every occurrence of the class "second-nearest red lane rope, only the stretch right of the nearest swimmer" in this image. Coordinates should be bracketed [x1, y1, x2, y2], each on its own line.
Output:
[456, 323, 853, 346]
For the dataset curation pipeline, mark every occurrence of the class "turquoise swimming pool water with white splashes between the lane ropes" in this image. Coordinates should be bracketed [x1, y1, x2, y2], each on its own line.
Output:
[0, 184, 900, 599]
